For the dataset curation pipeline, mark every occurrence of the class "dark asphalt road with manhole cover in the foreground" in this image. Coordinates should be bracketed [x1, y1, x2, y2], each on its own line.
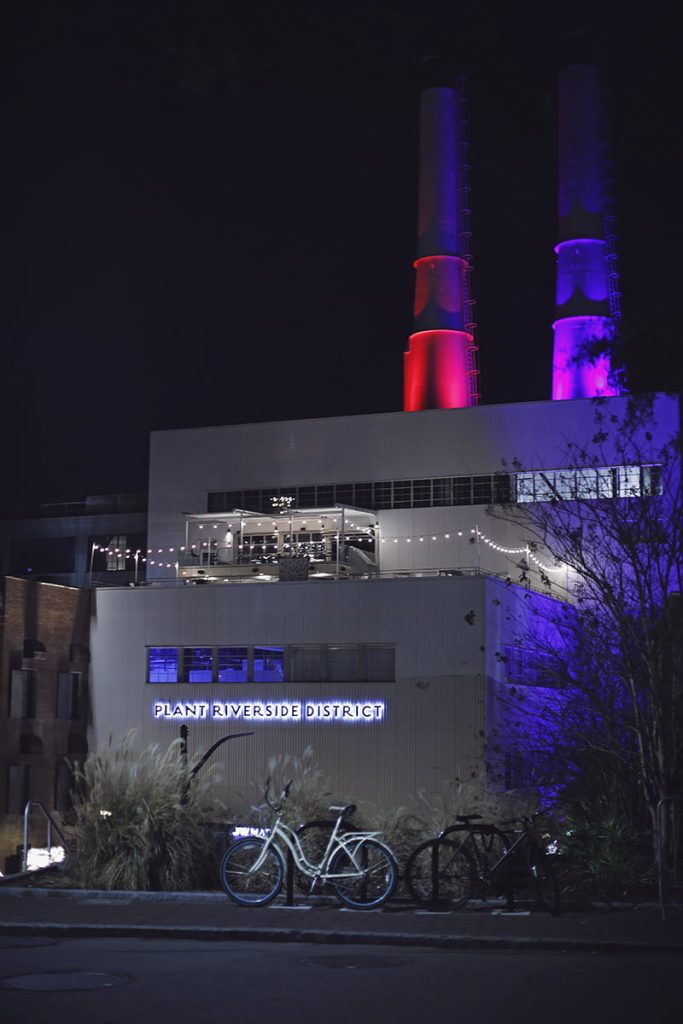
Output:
[0, 936, 683, 1024]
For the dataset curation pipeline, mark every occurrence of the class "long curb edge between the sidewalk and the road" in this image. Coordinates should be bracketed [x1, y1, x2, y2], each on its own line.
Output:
[0, 922, 683, 955]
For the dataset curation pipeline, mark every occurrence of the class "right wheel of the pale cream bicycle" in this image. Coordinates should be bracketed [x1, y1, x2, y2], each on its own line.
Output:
[329, 839, 398, 910]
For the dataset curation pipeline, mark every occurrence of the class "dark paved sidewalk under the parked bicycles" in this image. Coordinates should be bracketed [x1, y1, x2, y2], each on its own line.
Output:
[0, 886, 683, 953]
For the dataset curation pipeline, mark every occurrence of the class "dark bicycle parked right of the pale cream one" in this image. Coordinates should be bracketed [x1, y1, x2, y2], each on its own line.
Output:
[405, 814, 559, 913]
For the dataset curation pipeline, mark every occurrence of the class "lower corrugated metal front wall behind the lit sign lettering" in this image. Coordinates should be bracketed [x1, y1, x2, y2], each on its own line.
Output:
[91, 578, 493, 815]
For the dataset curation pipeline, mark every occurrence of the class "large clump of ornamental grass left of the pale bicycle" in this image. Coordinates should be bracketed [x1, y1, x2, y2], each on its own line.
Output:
[69, 733, 223, 891]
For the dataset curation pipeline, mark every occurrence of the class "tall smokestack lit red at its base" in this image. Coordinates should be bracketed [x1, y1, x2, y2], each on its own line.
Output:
[403, 62, 478, 412]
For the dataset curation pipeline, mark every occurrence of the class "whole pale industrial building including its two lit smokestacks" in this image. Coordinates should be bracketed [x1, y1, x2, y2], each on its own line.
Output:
[0, 59, 679, 864]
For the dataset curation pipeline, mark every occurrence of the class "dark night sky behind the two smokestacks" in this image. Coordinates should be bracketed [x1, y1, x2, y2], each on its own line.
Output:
[0, 0, 683, 504]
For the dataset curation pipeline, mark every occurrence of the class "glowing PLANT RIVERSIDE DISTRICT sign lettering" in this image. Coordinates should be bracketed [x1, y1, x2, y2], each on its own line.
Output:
[152, 700, 386, 725]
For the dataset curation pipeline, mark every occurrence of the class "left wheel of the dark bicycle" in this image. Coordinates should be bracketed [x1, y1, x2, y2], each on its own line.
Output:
[405, 839, 474, 910]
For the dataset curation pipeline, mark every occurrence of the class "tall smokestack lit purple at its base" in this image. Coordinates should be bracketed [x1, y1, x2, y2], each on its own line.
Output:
[553, 63, 621, 399]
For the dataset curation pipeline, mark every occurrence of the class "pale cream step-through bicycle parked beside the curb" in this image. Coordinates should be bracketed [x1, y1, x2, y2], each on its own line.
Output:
[220, 782, 398, 909]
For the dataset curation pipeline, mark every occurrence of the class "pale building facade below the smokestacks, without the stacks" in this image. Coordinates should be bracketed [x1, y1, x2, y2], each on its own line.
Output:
[90, 396, 678, 814]
